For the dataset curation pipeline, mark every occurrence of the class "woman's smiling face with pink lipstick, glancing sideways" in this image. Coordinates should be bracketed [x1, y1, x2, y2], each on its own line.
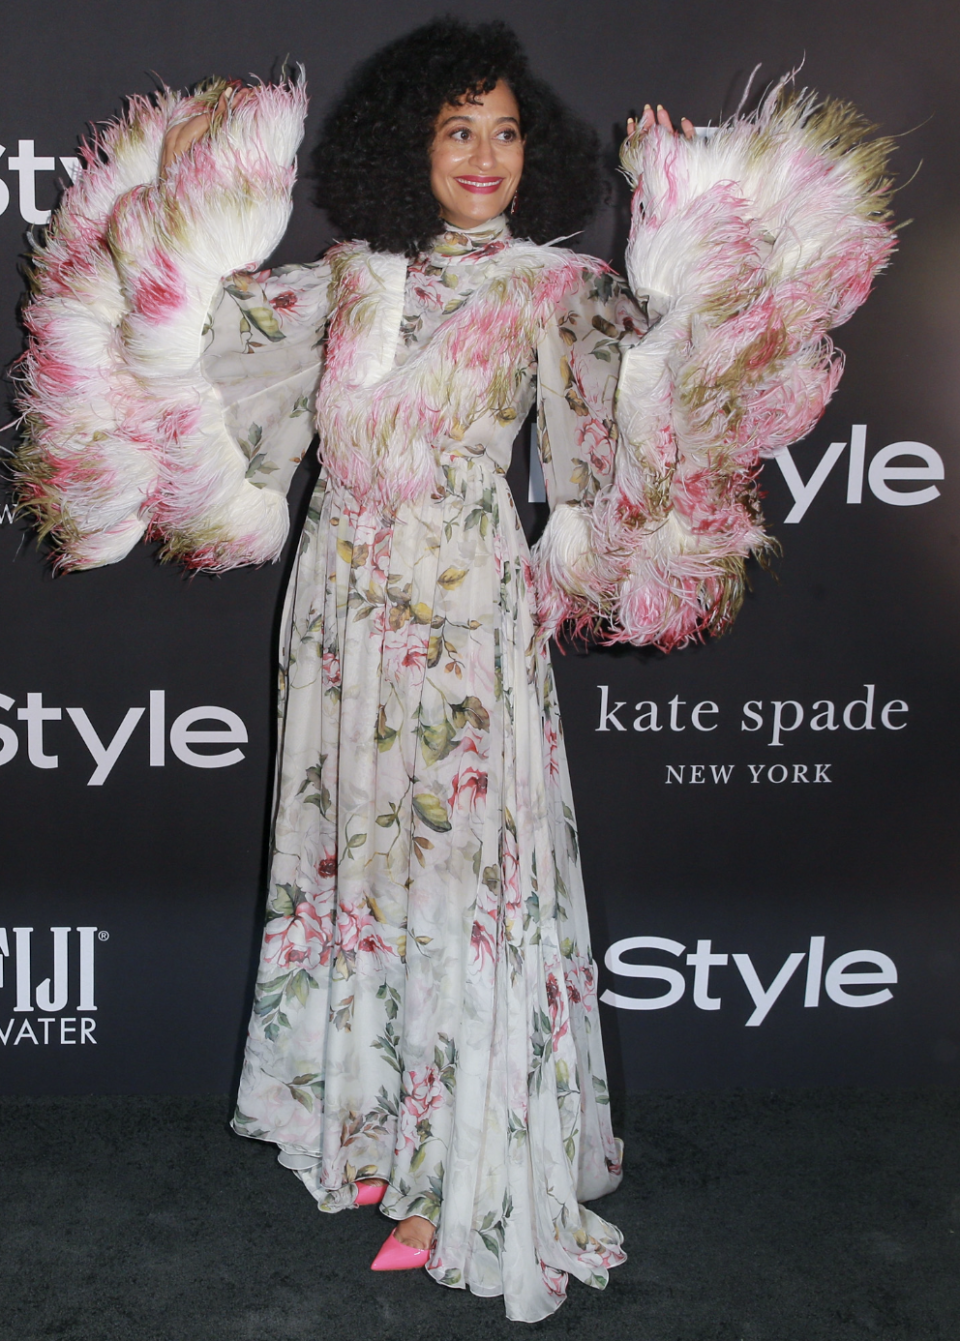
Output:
[430, 79, 523, 228]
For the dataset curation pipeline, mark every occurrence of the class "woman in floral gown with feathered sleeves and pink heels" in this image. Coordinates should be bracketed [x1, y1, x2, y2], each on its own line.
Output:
[20, 20, 890, 1321]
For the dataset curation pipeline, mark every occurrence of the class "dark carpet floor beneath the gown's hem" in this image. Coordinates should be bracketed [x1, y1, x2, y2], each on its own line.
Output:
[0, 1090, 960, 1341]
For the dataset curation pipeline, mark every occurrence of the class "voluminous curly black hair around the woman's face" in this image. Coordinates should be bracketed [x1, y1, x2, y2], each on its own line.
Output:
[314, 17, 602, 257]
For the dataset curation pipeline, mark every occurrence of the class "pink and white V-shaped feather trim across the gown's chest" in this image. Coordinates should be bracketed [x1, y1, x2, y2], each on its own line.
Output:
[316, 241, 606, 508]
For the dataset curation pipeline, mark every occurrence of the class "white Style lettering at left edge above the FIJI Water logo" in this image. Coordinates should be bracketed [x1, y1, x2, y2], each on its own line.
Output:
[0, 689, 248, 787]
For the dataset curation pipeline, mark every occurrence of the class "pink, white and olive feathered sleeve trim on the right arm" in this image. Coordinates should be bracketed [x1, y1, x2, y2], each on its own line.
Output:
[539, 82, 894, 649]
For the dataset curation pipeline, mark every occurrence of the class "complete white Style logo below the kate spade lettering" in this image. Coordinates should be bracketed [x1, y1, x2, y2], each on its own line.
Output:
[601, 936, 897, 1029]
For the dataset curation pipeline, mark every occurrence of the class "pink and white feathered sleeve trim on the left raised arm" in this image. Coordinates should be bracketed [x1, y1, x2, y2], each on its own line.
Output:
[16, 80, 306, 569]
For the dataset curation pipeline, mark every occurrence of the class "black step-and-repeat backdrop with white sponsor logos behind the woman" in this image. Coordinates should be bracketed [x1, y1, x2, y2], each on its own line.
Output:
[0, 0, 960, 1094]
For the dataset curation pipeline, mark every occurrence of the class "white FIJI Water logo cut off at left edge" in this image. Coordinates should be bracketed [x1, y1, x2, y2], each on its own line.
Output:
[0, 927, 102, 1047]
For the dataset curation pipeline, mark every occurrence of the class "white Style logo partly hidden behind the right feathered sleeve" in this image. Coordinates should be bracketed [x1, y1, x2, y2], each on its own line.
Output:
[776, 424, 944, 524]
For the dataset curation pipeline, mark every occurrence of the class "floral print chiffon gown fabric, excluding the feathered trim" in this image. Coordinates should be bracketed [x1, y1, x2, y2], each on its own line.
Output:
[205, 221, 641, 1321]
